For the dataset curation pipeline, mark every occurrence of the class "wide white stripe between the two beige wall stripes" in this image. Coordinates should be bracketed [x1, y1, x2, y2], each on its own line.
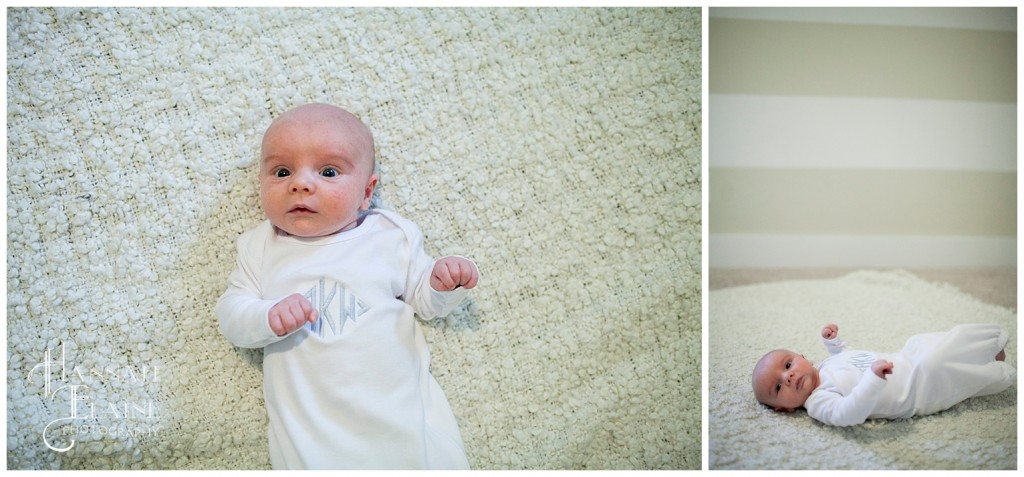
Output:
[709, 94, 1017, 172]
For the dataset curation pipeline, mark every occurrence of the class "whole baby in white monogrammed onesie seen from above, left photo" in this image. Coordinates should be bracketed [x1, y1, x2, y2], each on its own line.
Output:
[216, 104, 479, 469]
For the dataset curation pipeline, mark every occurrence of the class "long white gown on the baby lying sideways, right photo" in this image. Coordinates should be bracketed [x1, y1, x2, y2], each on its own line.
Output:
[804, 324, 1017, 426]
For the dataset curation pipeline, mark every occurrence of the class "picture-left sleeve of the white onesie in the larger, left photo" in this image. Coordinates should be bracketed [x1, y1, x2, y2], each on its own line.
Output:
[216, 228, 285, 348]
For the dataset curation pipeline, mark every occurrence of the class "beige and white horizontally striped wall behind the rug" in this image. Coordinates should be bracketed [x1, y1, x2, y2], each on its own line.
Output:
[707, 8, 1017, 268]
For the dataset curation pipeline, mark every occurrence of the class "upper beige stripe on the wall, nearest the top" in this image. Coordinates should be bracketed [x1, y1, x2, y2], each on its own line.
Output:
[708, 17, 1017, 102]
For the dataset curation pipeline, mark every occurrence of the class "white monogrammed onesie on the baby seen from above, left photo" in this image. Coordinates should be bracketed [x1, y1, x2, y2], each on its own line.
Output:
[217, 210, 469, 469]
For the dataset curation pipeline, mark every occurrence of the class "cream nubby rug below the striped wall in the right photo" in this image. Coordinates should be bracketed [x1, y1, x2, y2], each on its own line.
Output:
[708, 271, 1017, 469]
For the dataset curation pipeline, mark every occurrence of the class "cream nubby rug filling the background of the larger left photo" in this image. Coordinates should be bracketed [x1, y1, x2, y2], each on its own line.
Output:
[6, 8, 701, 469]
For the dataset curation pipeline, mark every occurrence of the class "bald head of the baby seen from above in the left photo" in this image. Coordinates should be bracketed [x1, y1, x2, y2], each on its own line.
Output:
[259, 103, 377, 236]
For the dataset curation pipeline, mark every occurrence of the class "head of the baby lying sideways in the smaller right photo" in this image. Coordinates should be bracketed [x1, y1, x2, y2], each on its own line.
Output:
[752, 349, 820, 413]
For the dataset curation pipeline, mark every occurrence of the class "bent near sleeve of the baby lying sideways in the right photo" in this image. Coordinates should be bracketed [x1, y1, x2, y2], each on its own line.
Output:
[804, 372, 886, 427]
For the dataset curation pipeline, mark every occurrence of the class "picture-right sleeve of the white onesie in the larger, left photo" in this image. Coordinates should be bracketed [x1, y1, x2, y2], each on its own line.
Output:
[391, 212, 475, 320]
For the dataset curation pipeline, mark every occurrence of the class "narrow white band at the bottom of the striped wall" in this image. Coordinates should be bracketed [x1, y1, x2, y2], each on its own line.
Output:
[708, 234, 1017, 268]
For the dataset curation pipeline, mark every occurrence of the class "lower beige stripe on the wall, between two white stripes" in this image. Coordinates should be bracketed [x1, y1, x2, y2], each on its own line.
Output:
[707, 167, 1017, 236]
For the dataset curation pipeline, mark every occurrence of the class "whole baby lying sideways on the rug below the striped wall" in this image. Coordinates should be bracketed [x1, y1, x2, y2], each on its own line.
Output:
[752, 324, 1017, 426]
